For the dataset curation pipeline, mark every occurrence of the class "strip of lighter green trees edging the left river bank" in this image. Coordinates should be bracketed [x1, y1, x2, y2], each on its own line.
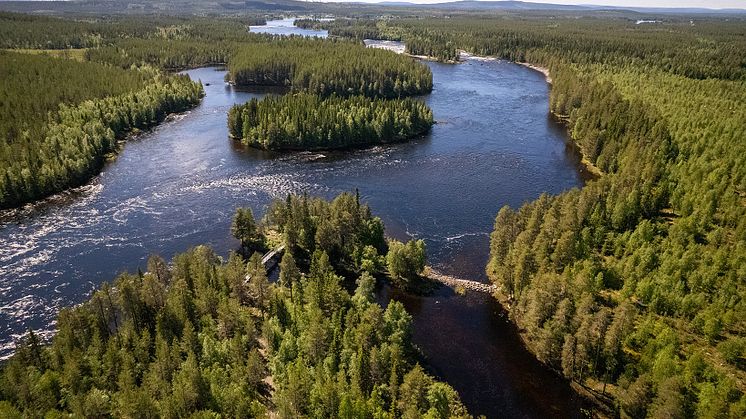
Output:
[0, 76, 204, 210]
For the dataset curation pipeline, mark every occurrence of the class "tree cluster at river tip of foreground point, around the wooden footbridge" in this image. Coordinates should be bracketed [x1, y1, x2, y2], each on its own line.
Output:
[256, 191, 426, 289]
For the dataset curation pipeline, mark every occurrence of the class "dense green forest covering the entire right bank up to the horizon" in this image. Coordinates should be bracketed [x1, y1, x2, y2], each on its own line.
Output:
[304, 10, 746, 417]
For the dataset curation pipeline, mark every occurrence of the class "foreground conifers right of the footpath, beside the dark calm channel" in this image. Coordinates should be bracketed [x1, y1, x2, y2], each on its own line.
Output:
[264, 246, 470, 418]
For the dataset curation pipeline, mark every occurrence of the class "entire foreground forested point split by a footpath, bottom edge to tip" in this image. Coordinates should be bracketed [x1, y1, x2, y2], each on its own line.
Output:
[0, 194, 469, 418]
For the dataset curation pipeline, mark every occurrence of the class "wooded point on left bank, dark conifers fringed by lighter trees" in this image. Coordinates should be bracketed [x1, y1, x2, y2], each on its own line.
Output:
[0, 52, 203, 208]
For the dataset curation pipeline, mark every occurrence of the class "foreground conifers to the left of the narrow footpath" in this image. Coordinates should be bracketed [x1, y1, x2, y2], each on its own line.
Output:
[0, 247, 263, 417]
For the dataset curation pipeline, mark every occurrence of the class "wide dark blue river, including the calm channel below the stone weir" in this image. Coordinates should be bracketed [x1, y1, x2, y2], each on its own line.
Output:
[0, 25, 583, 417]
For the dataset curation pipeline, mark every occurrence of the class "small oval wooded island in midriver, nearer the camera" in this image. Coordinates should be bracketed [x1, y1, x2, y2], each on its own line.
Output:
[228, 93, 433, 150]
